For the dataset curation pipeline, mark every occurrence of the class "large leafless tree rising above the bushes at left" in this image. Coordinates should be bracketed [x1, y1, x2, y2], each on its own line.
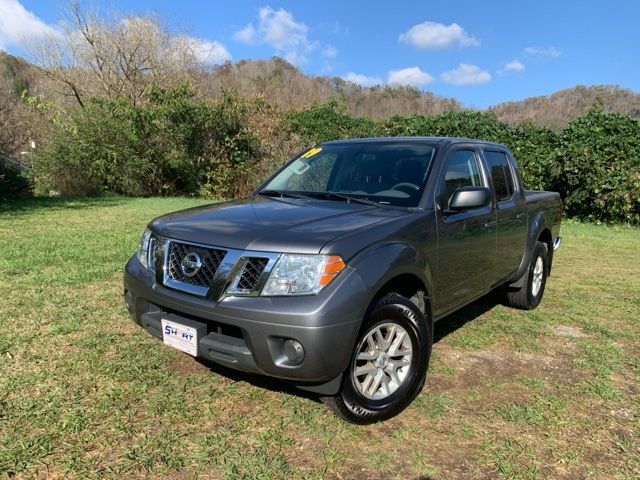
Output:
[32, 0, 199, 106]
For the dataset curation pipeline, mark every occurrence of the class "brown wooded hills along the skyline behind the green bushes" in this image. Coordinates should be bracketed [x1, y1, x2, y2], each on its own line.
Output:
[0, 51, 640, 128]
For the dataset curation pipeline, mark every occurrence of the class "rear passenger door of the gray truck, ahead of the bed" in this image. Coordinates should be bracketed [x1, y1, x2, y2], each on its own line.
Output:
[483, 147, 527, 280]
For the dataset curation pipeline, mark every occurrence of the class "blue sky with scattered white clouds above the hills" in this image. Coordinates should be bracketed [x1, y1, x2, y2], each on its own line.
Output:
[0, 0, 640, 107]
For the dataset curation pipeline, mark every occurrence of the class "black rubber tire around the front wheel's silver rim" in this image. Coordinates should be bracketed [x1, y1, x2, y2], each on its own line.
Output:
[341, 296, 431, 421]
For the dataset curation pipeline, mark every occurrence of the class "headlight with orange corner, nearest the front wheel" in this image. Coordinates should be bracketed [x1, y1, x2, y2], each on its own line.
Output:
[261, 253, 345, 296]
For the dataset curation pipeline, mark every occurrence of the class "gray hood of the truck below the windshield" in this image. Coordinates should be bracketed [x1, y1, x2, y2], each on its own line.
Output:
[150, 196, 408, 253]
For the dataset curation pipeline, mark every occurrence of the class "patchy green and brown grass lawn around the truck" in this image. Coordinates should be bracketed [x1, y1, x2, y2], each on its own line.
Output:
[0, 198, 640, 479]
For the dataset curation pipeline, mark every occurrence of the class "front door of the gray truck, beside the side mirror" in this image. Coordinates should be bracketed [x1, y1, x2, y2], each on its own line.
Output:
[435, 145, 497, 314]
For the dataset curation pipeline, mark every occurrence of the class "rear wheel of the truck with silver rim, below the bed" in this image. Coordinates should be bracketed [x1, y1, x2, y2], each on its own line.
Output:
[507, 242, 549, 310]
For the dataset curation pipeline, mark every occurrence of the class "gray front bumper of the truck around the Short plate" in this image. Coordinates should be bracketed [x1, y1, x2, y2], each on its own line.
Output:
[124, 255, 368, 394]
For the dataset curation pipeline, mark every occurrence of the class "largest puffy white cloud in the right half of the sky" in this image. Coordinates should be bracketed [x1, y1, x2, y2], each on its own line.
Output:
[399, 22, 480, 49]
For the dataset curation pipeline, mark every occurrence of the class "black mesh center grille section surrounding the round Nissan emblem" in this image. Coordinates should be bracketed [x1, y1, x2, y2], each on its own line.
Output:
[167, 241, 227, 288]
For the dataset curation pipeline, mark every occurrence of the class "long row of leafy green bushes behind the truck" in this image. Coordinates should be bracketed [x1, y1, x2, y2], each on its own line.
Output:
[35, 85, 640, 224]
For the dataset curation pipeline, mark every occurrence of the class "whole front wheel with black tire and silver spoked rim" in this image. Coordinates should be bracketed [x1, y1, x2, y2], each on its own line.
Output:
[322, 294, 432, 425]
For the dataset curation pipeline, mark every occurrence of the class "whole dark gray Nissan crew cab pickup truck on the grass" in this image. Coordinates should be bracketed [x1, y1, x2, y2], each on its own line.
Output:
[124, 137, 562, 423]
